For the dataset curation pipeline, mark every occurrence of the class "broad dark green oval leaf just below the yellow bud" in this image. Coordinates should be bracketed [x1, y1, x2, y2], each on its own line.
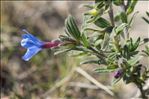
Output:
[94, 17, 110, 28]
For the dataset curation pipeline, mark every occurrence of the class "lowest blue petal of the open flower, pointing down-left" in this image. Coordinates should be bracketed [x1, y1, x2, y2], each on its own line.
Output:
[22, 46, 42, 61]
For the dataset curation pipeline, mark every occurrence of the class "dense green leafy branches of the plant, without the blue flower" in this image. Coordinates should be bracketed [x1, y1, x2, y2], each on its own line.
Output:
[56, 0, 149, 96]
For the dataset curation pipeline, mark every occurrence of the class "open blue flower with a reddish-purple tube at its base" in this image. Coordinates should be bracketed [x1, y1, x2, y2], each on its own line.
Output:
[21, 30, 60, 61]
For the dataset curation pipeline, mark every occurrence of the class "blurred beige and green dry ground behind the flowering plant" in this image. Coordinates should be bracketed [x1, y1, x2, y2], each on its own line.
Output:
[0, 1, 149, 99]
